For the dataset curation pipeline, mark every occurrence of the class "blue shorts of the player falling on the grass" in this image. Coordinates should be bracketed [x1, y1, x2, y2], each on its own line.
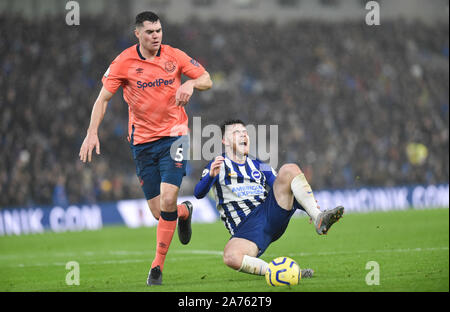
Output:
[232, 189, 303, 257]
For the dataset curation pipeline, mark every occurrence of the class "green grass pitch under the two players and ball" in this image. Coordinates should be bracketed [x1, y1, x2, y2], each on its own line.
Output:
[0, 209, 449, 292]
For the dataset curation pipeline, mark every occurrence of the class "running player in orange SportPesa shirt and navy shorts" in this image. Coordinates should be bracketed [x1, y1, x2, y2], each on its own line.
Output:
[79, 12, 212, 285]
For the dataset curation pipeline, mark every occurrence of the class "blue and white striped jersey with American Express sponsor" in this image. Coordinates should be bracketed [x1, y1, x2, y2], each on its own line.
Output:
[194, 154, 276, 235]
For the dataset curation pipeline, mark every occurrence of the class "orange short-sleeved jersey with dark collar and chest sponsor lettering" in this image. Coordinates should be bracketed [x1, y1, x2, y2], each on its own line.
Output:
[102, 44, 205, 145]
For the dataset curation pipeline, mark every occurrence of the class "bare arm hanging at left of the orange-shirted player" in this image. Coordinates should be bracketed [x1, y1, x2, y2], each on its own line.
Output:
[79, 87, 114, 163]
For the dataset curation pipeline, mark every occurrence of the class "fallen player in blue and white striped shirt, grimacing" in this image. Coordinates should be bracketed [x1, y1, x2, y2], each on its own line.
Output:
[194, 120, 344, 278]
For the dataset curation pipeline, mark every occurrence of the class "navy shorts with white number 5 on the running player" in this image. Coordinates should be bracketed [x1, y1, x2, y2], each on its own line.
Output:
[130, 136, 189, 200]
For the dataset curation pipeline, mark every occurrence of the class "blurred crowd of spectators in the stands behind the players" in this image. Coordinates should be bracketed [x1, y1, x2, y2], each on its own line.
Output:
[0, 15, 449, 207]
